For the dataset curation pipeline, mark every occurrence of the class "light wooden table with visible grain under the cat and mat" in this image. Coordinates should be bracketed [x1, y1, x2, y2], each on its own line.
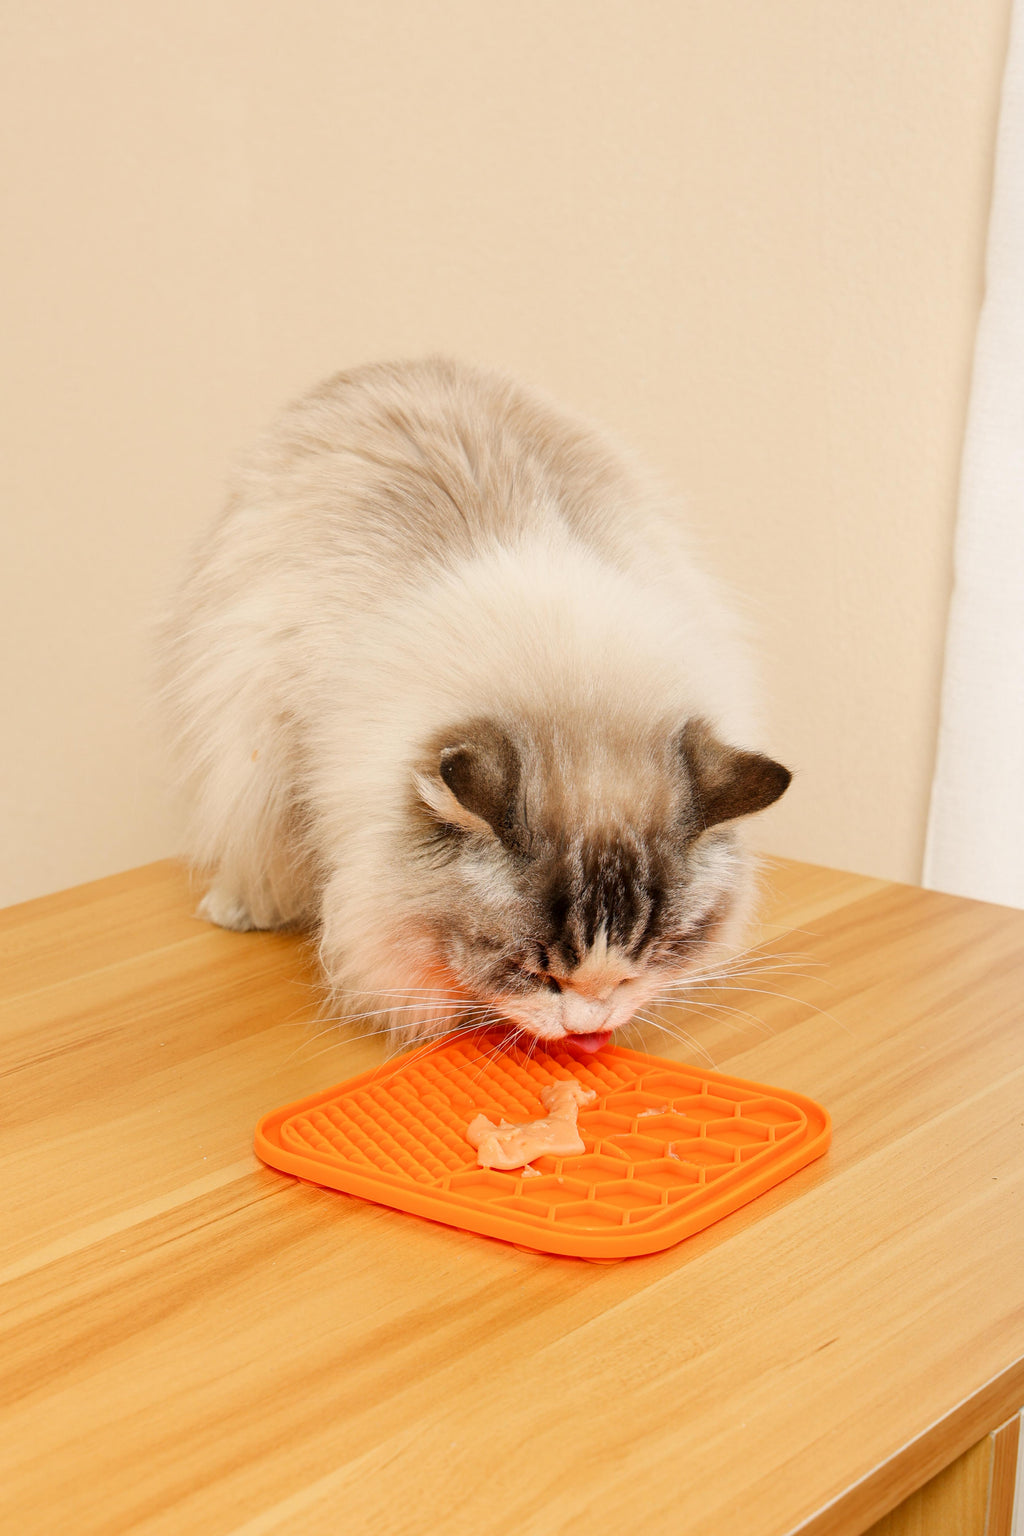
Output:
[0, 863, 1024, 1536]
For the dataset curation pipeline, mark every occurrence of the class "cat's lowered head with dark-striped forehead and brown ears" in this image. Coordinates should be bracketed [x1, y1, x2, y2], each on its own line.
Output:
[410, 717, 791, 1049]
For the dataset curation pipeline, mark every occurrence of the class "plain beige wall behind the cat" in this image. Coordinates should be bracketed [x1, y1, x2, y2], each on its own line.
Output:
[0, 0, 1009, 900]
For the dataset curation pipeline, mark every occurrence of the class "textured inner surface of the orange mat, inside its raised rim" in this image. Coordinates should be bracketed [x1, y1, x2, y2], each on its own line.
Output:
[281, 1035, 806, 1232]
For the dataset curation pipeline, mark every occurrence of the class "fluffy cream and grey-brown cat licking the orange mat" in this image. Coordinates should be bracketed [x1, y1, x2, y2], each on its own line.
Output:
[160, 358, 791, 1051]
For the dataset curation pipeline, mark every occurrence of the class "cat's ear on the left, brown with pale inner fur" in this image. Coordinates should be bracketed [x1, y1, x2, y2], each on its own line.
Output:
[415, 720, 522, 848]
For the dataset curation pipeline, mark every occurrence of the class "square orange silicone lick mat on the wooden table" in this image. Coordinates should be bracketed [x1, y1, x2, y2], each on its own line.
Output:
[256, 1029, 832, 1260]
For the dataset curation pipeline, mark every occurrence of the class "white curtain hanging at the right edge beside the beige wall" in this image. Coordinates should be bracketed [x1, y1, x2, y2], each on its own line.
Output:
[924, 8, 1024, 906]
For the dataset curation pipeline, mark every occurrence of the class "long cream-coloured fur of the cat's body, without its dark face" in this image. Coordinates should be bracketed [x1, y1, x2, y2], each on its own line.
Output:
[161, 359, 767, 1034]
